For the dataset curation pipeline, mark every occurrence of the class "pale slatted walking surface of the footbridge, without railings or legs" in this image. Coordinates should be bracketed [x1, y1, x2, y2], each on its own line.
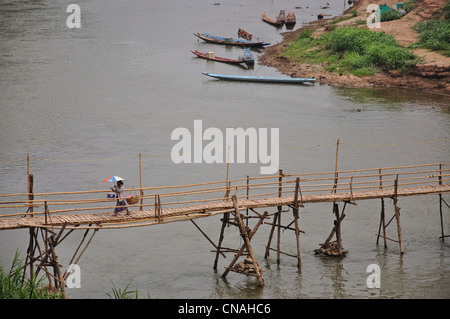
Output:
[0, 184, 450, 230]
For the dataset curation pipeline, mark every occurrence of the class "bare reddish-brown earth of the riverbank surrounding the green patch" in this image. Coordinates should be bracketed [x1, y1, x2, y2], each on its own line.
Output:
[258, 0, 450, 96]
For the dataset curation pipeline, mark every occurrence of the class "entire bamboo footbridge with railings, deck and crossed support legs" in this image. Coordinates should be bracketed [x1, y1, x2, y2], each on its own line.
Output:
[0, 159, 450, 294]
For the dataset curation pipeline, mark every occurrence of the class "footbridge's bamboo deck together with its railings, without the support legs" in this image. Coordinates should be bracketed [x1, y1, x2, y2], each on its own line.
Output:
[0, 164, 450, 230]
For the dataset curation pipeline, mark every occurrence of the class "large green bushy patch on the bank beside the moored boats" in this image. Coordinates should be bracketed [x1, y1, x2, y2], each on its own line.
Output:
[282, 27, 417, 76]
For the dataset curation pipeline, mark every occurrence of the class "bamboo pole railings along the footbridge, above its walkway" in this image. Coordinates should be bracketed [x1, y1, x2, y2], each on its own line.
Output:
[0, 163, 450, 229]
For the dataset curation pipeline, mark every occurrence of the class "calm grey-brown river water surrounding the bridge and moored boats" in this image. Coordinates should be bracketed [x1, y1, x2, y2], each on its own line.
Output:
[0, 0, 450, 299]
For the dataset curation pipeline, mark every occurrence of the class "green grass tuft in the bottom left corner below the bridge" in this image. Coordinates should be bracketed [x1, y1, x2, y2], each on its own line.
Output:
[0, 252, 62, 299]
